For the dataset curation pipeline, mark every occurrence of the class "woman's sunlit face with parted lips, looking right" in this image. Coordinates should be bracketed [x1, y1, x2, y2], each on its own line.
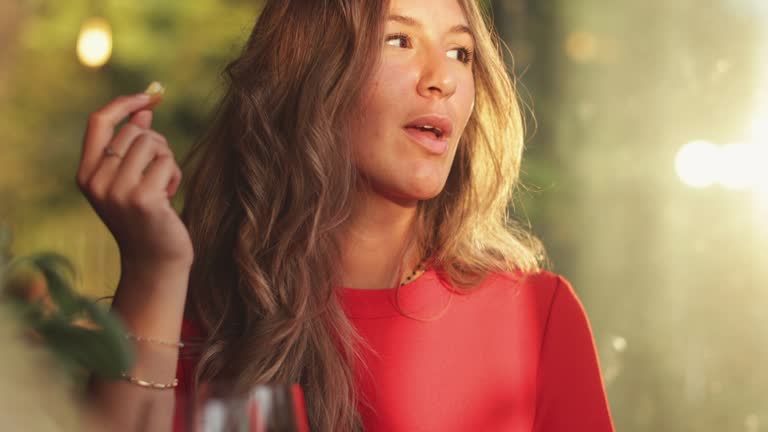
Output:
[352, 0, 475, 202]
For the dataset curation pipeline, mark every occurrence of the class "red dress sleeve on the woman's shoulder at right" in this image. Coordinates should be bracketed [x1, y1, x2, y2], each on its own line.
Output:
[533, 277, 614, 432]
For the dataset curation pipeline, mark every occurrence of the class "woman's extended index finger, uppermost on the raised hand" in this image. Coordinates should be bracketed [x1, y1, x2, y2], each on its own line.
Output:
[77, 93, 150, 187]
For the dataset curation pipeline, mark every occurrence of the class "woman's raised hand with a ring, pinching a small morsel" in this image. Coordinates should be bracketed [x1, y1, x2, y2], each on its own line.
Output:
[77, 93, 194, 269]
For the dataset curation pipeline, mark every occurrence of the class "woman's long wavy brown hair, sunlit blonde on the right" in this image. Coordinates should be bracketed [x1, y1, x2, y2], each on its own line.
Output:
[182, 0, 543, 432]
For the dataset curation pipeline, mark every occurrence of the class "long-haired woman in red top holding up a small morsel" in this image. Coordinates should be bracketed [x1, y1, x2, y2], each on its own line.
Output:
[78, 0, 612, 431]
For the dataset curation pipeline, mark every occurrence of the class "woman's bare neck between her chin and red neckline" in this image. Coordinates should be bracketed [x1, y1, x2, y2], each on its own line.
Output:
[340, 193, 422, 289]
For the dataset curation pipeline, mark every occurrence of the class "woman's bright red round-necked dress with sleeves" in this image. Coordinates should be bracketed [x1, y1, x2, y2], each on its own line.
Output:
[176, 270, 614, 432]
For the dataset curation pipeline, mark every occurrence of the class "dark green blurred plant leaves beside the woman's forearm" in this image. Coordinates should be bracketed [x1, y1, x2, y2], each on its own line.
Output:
[0, 253, 134, 384]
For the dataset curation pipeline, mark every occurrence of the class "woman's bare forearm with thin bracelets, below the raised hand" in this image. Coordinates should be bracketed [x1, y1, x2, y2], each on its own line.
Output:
[89, 264, 189, 432]
